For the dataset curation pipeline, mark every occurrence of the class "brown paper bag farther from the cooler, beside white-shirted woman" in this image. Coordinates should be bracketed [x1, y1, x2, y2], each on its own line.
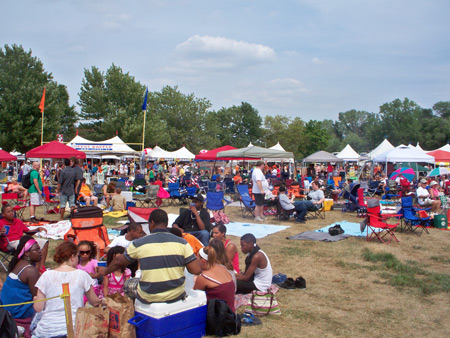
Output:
[75, 307, 109, 338]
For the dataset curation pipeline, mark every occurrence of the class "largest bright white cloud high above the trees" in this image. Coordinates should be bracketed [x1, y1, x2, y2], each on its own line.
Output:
[176, 35, 276, 69]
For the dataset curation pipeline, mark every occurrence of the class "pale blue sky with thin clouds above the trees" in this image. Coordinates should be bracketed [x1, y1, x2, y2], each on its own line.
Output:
[0, 0, 450, 121]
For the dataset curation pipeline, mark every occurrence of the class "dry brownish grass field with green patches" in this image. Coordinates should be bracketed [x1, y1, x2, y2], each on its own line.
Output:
[2, 202, 450, 338]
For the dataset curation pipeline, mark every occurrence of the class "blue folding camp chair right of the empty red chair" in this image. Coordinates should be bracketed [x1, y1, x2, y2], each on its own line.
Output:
[400, 196, 431, 236]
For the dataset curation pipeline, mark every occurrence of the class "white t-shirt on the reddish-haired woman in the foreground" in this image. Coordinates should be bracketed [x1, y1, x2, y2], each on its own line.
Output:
[33, 270, 94, 338]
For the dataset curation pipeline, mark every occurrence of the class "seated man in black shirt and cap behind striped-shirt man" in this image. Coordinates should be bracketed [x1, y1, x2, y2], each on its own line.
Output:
[172, 194, 211, 246]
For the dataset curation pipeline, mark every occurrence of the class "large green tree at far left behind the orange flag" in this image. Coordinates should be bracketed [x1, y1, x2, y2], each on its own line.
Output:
[0, 45, 77, 152]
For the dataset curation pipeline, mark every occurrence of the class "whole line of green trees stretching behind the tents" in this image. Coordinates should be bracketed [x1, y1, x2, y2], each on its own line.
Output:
[0, 45, 450, 159]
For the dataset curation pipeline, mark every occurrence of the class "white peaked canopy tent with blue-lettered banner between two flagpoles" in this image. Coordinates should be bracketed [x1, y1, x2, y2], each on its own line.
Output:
[67, 135, 137, 155]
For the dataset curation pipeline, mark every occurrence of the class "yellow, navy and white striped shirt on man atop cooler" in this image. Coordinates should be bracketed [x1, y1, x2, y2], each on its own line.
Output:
[124, 229, 197, 303]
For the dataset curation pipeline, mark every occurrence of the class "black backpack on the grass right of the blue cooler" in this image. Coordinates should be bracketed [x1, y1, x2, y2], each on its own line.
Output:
[206, 299, 241, 337]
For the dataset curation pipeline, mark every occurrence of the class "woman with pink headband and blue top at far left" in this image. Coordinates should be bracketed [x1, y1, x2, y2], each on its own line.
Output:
[0, 235, 42, 338]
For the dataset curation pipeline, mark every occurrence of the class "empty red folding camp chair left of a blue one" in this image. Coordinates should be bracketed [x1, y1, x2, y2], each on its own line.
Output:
[366, 198, 401, 244]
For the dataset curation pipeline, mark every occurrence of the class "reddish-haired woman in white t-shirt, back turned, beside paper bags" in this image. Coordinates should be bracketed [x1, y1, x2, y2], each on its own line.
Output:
[33, 242, 100, 338]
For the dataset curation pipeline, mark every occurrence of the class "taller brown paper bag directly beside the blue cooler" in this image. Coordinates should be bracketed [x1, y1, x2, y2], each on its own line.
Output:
[106, 293, 136, 338]
